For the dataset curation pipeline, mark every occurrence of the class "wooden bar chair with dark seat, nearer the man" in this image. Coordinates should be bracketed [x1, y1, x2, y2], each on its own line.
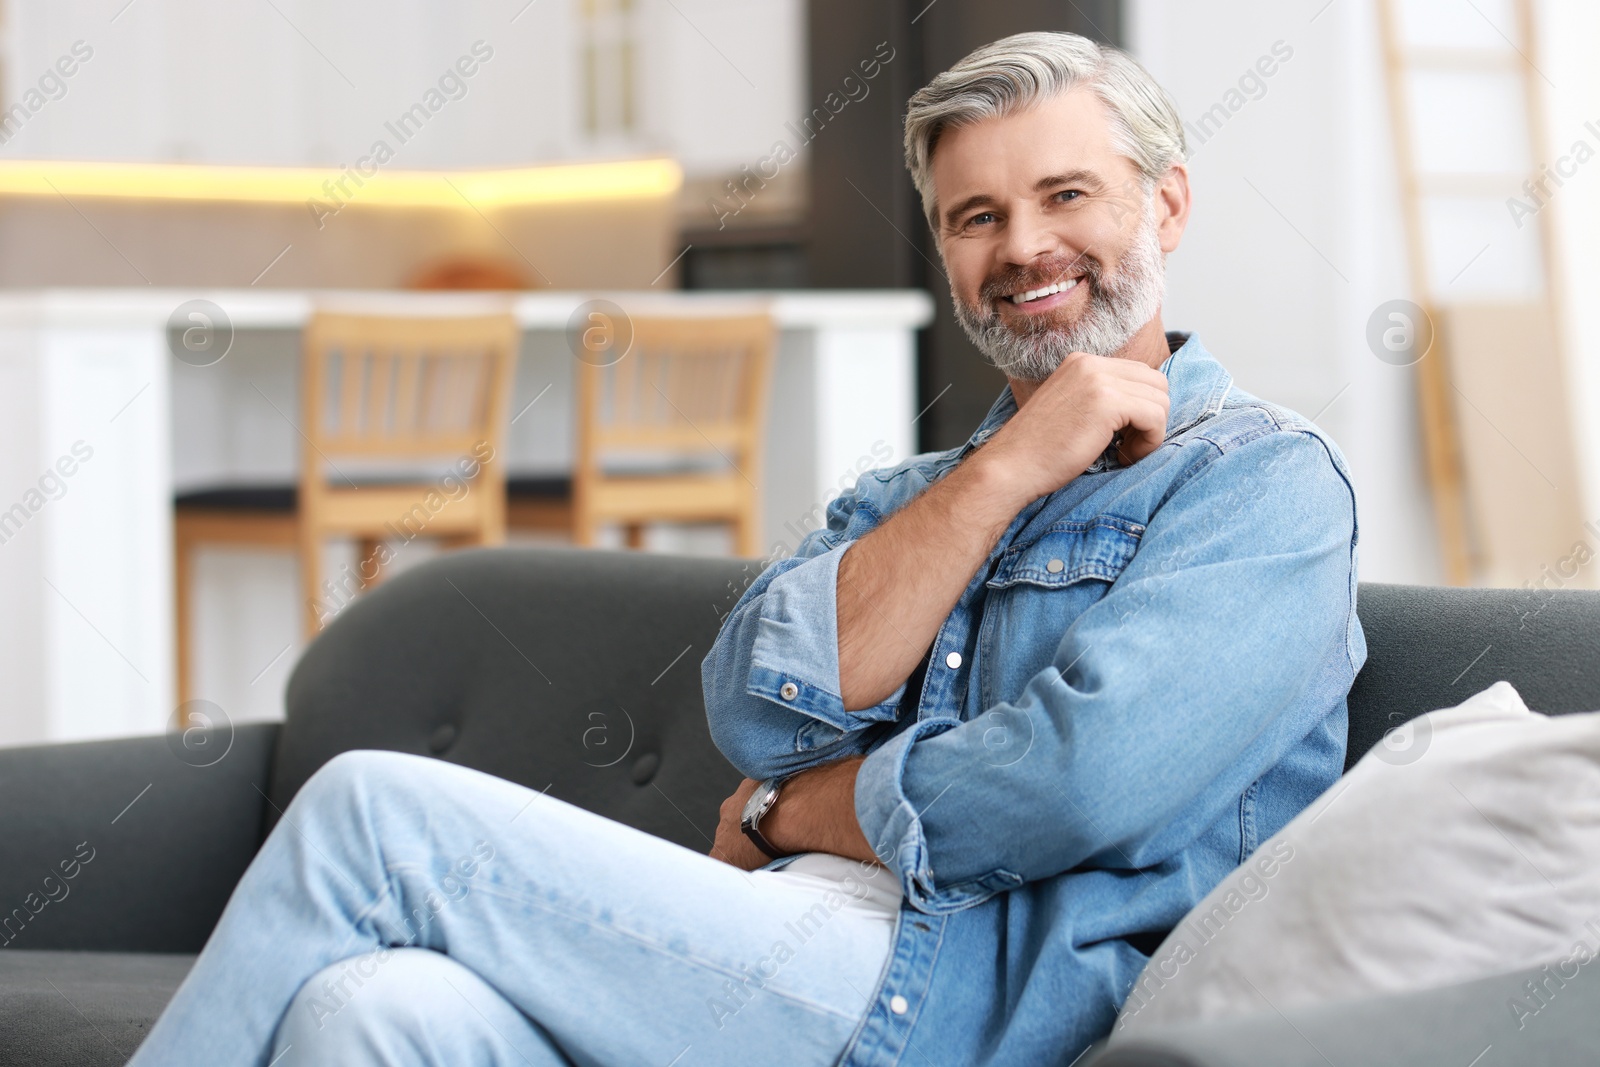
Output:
[509, 314, 776, 557]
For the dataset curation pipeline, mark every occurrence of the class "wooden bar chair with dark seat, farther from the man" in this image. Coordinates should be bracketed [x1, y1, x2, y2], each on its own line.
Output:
[174, 312, 518, 701]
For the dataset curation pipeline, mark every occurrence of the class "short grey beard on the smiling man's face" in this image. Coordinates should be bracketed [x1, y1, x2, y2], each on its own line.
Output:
[955, 203, 1166, 382]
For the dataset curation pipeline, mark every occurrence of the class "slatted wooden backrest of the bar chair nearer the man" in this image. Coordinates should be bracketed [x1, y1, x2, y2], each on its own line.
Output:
[578, 315, 774, 474]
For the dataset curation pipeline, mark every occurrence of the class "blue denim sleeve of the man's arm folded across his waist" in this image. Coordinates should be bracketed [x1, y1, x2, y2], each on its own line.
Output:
[856, 434, 1365, 913]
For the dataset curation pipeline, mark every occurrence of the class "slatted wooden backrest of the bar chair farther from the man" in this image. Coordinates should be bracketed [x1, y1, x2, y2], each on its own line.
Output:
[301, 312, 518, 480]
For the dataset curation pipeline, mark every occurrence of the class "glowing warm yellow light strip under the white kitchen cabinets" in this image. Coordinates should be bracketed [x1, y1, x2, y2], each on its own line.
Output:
[0, 160, 683, 208]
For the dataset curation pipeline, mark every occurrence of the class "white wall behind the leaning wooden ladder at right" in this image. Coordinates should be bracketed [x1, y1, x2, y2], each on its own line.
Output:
[1128, 0, 1600, 582]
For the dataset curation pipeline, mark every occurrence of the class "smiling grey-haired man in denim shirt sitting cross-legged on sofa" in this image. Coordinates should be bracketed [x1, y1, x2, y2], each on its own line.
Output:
[133, 34, 1365, 1067]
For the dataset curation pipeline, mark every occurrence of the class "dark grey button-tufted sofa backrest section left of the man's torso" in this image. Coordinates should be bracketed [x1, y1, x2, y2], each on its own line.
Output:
[269, 547, 758, 853]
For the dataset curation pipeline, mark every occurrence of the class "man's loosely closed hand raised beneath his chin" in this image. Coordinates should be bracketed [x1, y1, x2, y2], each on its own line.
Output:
[973, 352, 1171, 501]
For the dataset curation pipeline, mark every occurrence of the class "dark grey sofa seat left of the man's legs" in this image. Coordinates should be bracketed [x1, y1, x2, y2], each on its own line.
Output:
[0, 949, 195, 1067]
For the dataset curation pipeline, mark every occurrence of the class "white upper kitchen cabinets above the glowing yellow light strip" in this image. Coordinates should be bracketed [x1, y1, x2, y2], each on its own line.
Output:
[0, 0, 805, 174]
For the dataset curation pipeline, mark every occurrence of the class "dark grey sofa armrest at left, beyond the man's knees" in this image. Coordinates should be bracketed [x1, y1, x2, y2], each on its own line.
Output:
[0, 723, 278, 952]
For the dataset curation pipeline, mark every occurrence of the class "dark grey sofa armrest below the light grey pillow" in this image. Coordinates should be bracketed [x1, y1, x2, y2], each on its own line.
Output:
[1085, 959, 1600, 1067]
